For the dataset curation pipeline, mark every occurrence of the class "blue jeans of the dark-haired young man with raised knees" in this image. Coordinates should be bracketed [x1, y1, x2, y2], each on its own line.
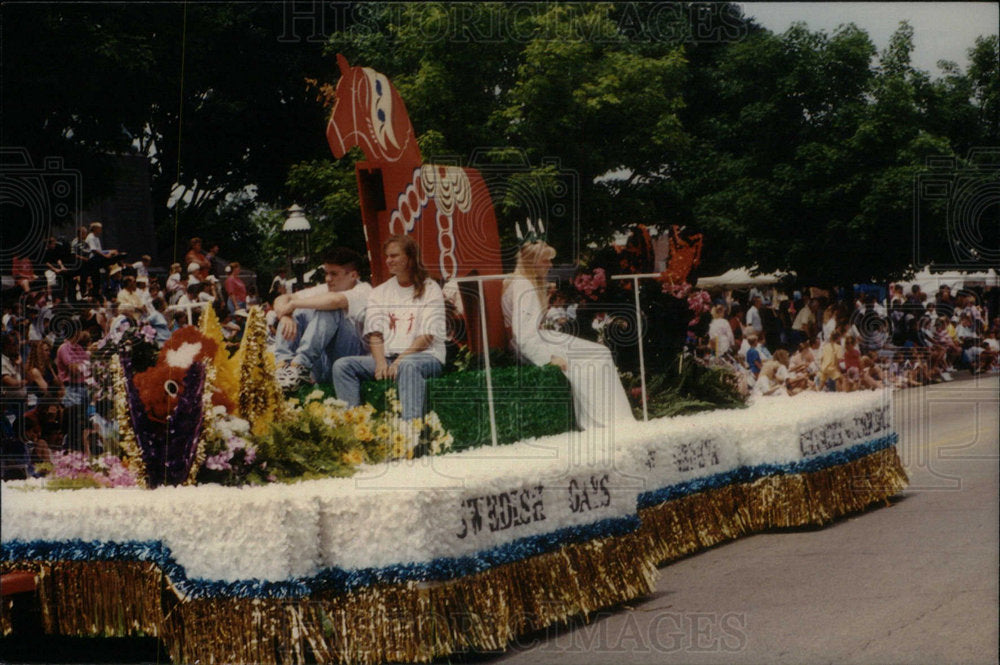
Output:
[274, 309, 365, 383]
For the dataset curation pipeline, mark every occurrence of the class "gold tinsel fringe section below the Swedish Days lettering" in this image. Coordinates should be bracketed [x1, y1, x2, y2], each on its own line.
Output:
[3, 533, 657, 664]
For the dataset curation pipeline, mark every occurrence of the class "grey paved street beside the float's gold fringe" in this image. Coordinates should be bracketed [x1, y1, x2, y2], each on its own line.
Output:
[489, 372, 1000, 665]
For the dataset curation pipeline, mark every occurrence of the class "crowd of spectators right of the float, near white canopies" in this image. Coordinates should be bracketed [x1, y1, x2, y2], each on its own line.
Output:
[689, 284, 1000, 399]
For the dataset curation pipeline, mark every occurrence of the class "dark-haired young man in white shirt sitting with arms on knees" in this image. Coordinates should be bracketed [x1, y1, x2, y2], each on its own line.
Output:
[274, 247, 372, 392]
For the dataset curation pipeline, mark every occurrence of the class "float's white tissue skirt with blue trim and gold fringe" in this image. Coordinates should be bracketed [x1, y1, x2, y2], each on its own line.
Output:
[0, 393, 906, 663]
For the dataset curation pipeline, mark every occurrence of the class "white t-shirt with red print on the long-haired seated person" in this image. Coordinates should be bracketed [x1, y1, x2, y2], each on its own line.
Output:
[364, 277, 447, 364]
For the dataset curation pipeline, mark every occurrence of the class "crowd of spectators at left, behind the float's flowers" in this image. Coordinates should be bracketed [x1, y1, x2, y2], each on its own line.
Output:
[0, 228, 259, 477]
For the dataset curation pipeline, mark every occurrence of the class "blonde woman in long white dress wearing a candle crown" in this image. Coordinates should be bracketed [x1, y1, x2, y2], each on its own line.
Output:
[501, 242, 635, 430]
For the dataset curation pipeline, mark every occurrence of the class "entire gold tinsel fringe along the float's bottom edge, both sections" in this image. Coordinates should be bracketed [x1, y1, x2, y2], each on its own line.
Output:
[0, 448, 907, 665]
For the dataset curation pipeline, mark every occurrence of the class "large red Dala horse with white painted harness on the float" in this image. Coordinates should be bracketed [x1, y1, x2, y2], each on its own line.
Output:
[326, 54, 505, 350]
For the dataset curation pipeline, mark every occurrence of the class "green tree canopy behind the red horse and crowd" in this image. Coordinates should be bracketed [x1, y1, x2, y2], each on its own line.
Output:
[2, 3, 1000, 283]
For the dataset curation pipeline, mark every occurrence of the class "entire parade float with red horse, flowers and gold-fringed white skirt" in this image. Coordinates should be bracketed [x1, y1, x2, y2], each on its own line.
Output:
[0, 58, 906, 663]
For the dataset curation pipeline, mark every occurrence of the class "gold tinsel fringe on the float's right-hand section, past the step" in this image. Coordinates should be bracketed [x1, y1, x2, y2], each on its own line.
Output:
[639, 447, 909, 564]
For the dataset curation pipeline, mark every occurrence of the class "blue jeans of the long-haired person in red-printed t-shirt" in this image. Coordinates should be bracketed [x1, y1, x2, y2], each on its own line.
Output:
[333, 353, 443, 420]
